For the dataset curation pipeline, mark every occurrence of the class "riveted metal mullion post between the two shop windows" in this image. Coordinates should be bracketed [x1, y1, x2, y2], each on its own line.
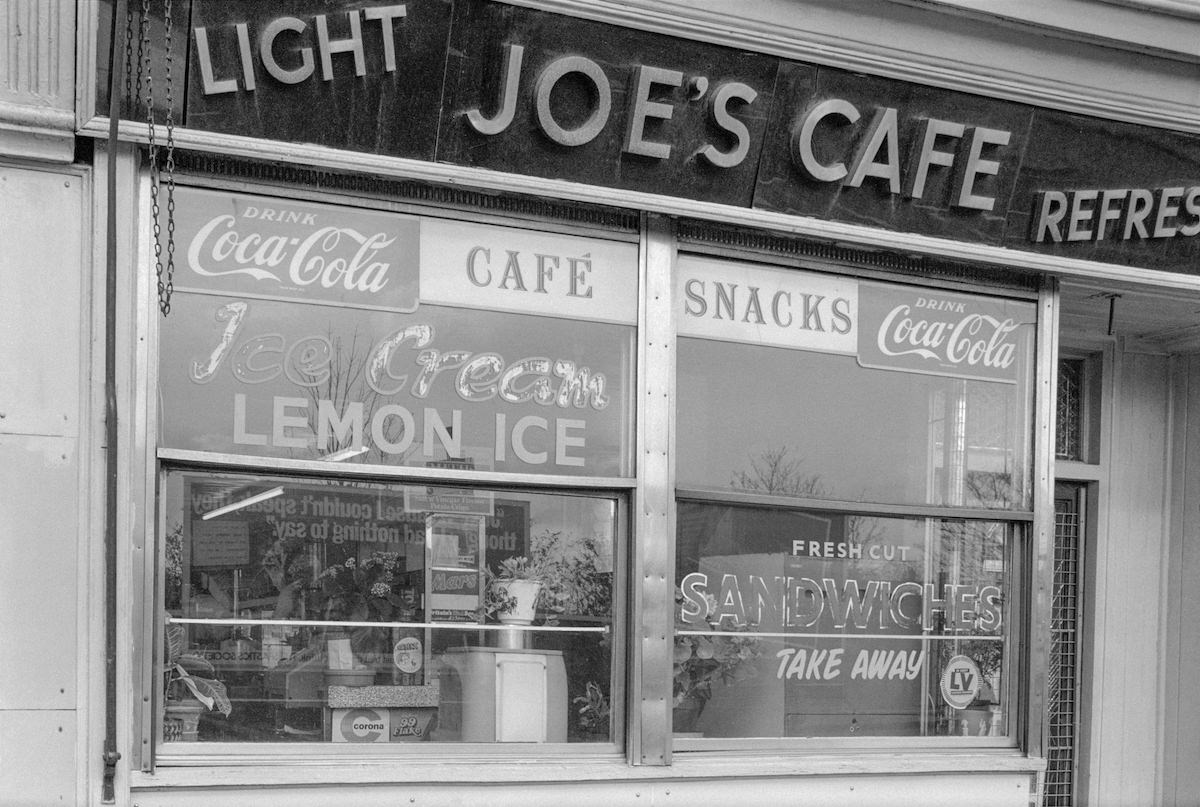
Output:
[629, 216, 676, 765]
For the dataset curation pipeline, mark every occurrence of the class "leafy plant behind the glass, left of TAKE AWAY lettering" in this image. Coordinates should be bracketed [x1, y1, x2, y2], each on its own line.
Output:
[672, 590, 762, 715]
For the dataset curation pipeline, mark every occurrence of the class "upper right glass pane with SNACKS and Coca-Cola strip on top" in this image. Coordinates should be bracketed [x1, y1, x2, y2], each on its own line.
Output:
[677, 257, 1034, 509]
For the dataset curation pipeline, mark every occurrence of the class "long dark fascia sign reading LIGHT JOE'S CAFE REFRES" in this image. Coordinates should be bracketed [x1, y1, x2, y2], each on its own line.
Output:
[108, 0, 1200, 274]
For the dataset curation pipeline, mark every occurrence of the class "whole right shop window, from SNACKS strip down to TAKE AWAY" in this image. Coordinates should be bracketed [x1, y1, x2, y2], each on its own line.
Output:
[673, 256, 1036, 749]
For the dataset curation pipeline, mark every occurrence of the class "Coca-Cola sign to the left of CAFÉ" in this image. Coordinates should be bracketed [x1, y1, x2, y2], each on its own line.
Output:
[175, 187, 420, 312]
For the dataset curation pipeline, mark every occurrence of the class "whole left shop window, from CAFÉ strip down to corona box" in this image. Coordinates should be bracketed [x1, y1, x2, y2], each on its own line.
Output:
[152, 185, 638, 760]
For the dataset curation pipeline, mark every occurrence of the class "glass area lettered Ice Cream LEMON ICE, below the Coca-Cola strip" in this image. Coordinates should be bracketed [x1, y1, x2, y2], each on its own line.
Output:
[161, 293, 632, 476]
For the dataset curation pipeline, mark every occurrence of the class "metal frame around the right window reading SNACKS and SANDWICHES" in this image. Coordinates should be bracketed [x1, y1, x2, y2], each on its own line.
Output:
[662, 237, 1058, 757]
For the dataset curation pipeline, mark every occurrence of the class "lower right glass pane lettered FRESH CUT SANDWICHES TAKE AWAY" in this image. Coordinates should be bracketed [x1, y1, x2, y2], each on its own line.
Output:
[673, 502, 1018, 737]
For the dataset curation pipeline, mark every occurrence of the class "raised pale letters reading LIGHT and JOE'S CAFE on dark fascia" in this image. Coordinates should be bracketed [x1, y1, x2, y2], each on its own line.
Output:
[193, 4, 1012, 210]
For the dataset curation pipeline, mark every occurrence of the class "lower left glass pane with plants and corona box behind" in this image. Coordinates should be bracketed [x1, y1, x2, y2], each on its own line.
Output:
[161, 471, 619, 742]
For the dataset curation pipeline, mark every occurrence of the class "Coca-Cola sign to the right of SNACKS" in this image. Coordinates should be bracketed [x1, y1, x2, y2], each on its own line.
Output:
[858, 283, 1033, 383]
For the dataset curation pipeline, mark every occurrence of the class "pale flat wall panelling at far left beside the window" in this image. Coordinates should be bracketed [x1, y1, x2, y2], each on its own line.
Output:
[0, 163, 90, 807]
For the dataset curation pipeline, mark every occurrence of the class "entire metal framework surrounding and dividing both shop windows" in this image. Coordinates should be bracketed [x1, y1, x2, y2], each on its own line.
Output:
[126, 172, 1058, 773]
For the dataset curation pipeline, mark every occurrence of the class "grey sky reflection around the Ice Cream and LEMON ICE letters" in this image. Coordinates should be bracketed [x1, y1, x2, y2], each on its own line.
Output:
[160, 293, 632, 474]
